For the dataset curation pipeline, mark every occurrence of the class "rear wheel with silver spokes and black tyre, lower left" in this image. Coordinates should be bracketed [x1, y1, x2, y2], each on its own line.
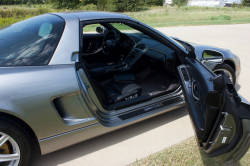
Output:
[0, 120, 31, 166]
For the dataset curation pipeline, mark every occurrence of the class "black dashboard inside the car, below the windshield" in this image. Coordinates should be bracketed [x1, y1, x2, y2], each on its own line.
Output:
[119, 33, 176, 75]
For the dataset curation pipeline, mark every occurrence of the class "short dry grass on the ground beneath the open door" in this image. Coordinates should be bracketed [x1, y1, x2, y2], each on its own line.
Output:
[129, 137, 250, 166]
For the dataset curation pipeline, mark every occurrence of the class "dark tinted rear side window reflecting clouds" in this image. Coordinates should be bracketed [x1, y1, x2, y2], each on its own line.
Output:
[0, 14, 65, 66]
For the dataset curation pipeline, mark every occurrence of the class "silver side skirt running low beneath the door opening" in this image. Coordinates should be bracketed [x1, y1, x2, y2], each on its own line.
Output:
[39, 101, 185, 154]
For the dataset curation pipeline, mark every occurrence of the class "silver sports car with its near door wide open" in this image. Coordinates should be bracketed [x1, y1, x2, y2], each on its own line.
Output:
[0, 12, 247, 166]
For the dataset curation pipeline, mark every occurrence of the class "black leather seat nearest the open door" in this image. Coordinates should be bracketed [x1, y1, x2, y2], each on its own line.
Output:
[93, 80, 142, 104]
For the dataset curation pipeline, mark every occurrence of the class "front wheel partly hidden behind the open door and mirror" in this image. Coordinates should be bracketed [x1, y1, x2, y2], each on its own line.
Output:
[213, 63, 236, 85]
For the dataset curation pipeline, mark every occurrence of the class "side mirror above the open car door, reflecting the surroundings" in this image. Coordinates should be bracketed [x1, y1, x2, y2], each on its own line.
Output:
[202, 50, 224, 63]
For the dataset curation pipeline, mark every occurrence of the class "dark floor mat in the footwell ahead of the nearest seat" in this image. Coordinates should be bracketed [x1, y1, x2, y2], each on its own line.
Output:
[135, 68, 178, 95]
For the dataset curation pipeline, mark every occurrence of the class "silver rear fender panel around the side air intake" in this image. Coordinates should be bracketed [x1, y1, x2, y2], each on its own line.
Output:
[0, 65, 95, 139]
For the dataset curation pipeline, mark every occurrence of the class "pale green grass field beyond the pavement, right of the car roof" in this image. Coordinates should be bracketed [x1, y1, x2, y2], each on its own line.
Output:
[125, 7, 250, 27]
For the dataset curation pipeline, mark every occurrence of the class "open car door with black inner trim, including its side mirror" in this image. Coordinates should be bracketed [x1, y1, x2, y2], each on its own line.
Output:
[178, 50, 250, 164]
